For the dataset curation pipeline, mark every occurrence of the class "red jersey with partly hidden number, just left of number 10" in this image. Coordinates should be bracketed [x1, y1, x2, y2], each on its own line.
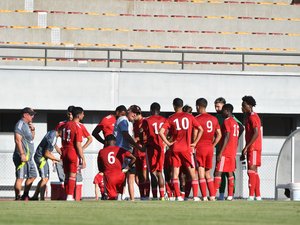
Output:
[142, 115, 166, 149]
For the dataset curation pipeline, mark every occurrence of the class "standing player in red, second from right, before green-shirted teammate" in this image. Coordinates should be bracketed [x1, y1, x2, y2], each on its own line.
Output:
[215, 104, 239, 201]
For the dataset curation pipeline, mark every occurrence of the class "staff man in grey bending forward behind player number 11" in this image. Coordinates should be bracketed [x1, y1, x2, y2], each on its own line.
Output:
[30, 129, 62, 200]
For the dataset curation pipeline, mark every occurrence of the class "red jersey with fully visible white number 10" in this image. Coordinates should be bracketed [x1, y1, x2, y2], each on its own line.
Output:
[162, 112, 200, 152]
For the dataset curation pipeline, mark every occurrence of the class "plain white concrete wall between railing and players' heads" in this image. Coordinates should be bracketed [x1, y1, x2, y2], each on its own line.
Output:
[0, 67, 300, 114]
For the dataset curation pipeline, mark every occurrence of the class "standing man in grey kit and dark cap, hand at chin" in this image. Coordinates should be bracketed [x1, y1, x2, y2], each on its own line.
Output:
[13, 107, 37, 200]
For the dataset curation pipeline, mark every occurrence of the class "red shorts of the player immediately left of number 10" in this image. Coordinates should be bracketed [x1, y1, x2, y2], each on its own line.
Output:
[147, 146, 165, 172]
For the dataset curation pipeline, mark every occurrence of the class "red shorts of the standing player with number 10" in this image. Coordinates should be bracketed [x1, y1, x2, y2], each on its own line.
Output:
[171, 151, 195, 168]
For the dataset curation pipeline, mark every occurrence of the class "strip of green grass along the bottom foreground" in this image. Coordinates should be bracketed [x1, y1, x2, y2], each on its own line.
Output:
[0, 200, 300, 225]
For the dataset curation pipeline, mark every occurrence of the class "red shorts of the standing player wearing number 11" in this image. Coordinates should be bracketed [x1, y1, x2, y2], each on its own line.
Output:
[62, 149, 79, 174]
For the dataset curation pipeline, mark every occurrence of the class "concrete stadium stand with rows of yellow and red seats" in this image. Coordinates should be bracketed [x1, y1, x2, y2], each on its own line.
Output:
[0, 0, 300, 71]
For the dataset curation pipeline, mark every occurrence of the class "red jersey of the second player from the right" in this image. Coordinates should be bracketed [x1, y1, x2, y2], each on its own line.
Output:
[220, 117, 240, 157]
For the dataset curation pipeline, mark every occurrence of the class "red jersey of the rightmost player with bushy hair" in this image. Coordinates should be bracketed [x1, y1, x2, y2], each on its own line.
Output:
[245, 112, 262, 151]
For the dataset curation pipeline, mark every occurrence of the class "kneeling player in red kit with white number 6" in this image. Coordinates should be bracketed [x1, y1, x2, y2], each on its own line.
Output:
[98, 134, 136, 200]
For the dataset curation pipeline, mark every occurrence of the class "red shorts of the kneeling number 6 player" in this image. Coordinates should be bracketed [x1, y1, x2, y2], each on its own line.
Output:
[104, 173, 125, 200]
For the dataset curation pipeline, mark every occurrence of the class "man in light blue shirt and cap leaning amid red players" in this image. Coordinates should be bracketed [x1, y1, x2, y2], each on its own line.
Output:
[114, 105, 144, 201]
